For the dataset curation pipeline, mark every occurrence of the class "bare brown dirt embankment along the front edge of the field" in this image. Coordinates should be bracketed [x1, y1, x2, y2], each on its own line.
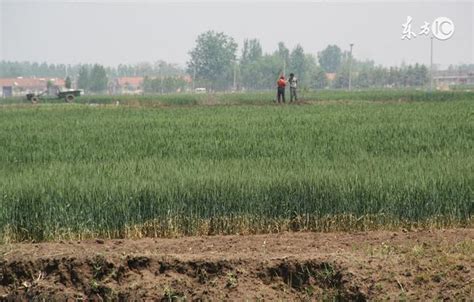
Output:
[0, 229, 474, 301]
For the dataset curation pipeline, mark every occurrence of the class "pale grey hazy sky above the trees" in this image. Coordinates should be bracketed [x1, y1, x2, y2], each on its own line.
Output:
[0, 0, 474, 67]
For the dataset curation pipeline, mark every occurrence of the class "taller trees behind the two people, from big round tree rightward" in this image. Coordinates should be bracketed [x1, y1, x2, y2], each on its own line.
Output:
[188, 31, 436, 90]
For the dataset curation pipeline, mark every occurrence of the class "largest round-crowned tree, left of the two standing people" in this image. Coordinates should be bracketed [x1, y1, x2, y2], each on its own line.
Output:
[188, 31, 237, 89]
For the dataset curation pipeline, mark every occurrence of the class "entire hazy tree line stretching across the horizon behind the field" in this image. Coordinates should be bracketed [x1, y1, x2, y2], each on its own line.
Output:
[0, 31, 474, 93]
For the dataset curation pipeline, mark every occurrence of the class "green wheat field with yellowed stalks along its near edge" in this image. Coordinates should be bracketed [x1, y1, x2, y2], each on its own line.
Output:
[0, 92, 474, 242]
